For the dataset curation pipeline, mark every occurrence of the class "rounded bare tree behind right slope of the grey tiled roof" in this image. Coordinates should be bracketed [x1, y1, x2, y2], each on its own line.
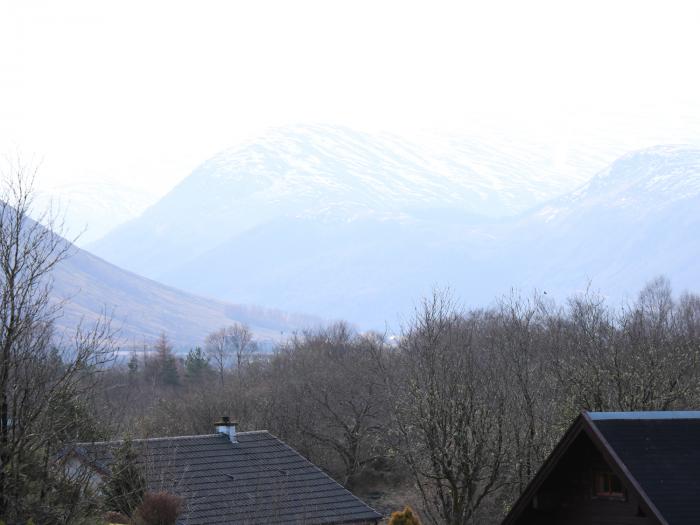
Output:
[278, 323, 388, 485]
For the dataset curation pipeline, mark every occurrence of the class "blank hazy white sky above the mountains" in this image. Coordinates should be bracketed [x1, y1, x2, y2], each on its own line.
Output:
[0, 0, 700, 193]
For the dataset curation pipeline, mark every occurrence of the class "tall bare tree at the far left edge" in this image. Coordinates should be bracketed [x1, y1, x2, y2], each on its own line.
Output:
[0, 164, 113, 522]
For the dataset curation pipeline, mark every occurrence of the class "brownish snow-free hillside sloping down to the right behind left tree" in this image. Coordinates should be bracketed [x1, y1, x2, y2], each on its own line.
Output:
[53, 243, 319, 348]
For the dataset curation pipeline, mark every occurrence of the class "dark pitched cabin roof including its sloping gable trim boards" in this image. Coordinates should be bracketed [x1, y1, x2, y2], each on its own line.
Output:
[503, 411, 700, 525]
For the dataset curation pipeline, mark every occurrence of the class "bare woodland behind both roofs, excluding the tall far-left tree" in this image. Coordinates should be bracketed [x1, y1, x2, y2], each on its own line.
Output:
[91, 278, 700, 524]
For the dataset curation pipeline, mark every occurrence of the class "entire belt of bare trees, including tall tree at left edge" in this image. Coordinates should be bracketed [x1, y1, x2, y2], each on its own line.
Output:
[0, 170, 700, 525]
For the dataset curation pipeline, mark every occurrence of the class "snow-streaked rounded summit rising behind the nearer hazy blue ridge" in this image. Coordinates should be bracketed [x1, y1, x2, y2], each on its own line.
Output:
[88, 126, 596, 283]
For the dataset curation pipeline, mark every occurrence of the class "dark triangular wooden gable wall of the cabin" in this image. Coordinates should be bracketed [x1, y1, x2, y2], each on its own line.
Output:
[516, 433, 658, 525]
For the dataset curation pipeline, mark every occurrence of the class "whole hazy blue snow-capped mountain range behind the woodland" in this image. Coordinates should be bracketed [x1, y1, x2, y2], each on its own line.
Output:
[86, 127, 700, 328]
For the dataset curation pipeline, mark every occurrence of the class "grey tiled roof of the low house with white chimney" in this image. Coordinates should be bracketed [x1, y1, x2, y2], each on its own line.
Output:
[75, 431, 381, 525]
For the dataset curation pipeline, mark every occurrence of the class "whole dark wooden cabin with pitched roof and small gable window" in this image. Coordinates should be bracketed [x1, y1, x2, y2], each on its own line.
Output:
[503, 412, 700, 525]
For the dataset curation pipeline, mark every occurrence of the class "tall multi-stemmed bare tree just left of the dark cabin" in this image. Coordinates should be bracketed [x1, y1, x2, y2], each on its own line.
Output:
[393, 293, 505, 525]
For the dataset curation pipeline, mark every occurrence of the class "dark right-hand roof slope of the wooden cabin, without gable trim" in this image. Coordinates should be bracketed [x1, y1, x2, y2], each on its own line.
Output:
[591, 412, 700, 525]
